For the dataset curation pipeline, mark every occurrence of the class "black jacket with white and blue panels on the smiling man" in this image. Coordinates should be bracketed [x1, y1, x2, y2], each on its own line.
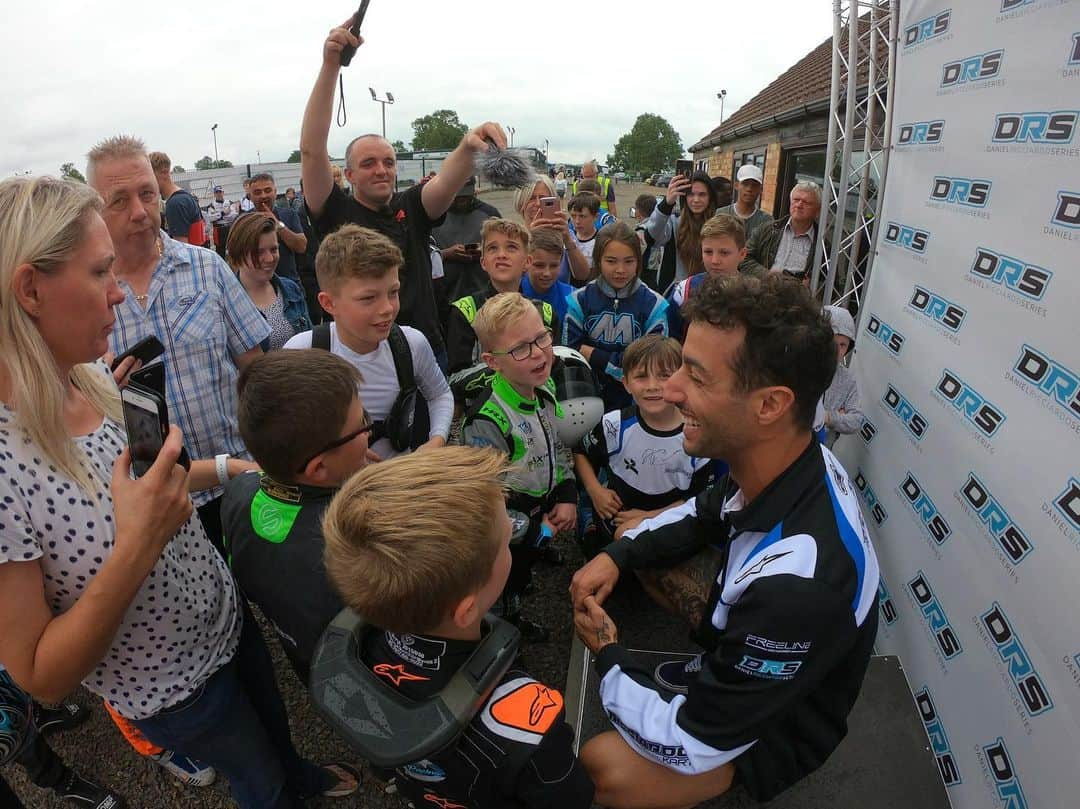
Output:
[596, 441, 878, 800]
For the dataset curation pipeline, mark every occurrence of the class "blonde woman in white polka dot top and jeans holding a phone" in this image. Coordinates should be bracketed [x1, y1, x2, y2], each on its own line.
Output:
[0, 177, 355, 807]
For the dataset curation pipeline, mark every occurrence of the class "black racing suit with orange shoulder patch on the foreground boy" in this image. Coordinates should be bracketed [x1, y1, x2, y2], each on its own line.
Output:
[361, 632, 593, 809]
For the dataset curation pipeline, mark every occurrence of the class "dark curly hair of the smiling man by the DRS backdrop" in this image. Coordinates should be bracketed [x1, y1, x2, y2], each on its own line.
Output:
[683, 273, 836, 430]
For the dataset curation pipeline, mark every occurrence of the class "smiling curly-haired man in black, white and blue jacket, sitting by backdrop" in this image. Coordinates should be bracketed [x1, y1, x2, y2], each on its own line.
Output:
[571, 275, 878, 807]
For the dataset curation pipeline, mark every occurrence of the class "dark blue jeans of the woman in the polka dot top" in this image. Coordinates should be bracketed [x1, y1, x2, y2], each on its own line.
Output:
[134, 599, 322, 809]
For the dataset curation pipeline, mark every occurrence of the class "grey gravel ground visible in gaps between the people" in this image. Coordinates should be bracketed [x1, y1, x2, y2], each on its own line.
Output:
[0, 185, 648, 809]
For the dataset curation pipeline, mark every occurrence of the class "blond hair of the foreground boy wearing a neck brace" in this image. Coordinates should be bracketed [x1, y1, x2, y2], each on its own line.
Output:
[323, 446, 507, 634]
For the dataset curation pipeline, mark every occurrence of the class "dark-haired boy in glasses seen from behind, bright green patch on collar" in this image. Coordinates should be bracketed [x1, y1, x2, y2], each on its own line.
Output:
[221, 349, 372, 684]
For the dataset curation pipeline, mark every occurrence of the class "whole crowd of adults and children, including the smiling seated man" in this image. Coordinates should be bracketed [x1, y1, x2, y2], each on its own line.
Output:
[0, 12, 877, 809]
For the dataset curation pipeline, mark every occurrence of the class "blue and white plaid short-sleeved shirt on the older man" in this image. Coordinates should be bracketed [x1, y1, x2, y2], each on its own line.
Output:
[109, 231, 270, 505]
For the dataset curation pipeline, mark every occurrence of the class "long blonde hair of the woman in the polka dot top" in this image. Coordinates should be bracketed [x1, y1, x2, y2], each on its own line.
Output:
[0, 177, 123, 494]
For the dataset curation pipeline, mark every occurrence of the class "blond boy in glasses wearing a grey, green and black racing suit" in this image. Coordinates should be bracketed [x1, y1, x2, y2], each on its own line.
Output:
[461, 293, 578, 641]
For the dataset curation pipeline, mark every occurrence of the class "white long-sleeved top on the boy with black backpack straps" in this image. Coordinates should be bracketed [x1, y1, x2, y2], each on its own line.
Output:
[285, 323, 454, 460]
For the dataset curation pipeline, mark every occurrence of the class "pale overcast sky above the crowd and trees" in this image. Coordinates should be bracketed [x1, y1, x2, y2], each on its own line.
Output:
[0, 0, 832, 177]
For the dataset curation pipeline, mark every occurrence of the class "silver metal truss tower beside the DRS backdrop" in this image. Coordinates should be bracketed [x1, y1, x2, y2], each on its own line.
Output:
[812, 0, 900, 319]
